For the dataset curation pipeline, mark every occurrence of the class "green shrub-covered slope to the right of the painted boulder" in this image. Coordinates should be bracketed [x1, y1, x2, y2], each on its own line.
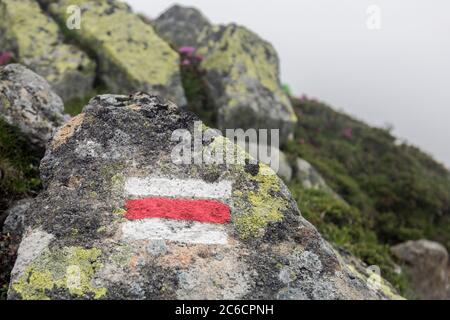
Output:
[285, 99, 450, 292]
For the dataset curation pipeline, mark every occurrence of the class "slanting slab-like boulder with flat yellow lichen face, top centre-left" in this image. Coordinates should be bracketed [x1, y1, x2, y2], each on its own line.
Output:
[49, 0, 186, 105]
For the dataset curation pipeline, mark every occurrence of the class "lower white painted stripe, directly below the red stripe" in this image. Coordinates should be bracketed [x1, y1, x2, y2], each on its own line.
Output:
[122, 218, 228, 245]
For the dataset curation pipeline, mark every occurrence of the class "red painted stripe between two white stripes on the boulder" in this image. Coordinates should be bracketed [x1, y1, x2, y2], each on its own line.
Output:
[125, 198, 230, 224]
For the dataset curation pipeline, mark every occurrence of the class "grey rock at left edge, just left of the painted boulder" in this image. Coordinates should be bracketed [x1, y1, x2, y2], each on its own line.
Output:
[0, 64, 69, 148]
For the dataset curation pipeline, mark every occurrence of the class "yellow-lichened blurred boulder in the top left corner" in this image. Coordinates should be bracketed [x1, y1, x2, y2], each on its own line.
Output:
[0, 0, 96, 99]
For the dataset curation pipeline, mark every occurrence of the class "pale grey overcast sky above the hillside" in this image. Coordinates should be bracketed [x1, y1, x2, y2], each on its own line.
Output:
[126, 0, 450, 167]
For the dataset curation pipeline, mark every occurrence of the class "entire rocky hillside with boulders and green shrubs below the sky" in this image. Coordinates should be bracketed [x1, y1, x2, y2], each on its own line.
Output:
[0, 0, 450, 299]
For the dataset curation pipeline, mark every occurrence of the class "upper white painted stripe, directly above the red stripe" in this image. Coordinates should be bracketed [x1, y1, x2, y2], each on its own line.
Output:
[125, 178, 232, 199]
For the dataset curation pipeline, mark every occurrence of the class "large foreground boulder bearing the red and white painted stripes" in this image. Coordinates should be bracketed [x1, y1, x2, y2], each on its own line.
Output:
[8, 94, 400, 299]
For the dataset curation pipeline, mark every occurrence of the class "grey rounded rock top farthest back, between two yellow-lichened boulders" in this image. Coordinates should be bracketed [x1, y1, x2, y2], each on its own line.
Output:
[153, 5, 212, 48]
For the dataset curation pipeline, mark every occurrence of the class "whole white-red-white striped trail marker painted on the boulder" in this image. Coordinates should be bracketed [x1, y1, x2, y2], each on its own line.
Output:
[122, 178, 232, 244]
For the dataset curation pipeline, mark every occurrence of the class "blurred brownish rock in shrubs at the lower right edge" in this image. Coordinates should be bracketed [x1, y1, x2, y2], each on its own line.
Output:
[391, 240, 449, 300]
